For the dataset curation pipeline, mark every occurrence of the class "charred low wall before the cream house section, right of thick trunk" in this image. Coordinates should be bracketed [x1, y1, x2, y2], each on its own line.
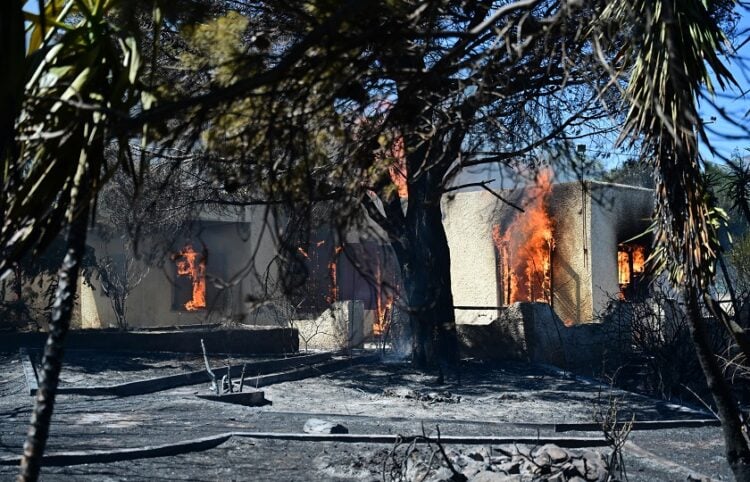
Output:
[458, 303, 629, 371]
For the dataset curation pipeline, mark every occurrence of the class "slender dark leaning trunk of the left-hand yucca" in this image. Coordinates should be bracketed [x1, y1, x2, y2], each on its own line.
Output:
[18, 202, 89, 482]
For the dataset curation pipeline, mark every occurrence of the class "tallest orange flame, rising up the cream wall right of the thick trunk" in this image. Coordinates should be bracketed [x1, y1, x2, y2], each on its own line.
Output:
[492, 171, 555, 304]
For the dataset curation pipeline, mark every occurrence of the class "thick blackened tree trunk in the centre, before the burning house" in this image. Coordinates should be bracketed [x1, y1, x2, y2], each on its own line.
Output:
[376, 42, 480, 370]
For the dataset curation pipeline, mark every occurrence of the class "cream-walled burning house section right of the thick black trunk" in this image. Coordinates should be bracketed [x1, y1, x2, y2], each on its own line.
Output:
[444, 179, 653, 363]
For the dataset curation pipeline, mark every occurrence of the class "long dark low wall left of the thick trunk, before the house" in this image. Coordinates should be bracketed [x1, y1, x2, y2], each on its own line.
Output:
[0, 327, 299, 355]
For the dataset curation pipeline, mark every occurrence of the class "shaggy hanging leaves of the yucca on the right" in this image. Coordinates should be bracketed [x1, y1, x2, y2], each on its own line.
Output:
[606, 0, 734, 288]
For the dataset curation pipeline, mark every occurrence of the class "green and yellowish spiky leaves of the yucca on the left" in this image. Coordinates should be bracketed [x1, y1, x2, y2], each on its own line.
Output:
[0, 0, 153, 272]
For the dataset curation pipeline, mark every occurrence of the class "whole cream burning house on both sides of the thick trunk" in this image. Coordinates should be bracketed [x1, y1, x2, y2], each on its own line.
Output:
[70, 165, 653, 362]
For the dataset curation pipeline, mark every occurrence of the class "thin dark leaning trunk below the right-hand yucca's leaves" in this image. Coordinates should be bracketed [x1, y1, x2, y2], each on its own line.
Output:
[684, 286, 750, 481]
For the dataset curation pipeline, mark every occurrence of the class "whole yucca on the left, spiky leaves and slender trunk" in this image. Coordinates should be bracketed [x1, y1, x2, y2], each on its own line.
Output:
[0, 0, 159, 481]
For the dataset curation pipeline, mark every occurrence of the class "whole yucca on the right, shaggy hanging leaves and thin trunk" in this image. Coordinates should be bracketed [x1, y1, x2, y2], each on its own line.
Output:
[602, 0, 750, 480]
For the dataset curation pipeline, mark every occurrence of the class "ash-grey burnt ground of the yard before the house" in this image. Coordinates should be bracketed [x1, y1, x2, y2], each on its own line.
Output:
[0, 352, 731, 481]
